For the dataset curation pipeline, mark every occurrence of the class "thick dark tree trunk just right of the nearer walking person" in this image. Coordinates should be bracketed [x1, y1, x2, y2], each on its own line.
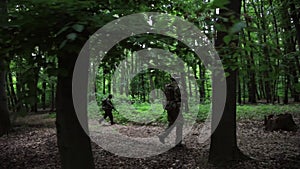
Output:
[209, 0, 246, 165]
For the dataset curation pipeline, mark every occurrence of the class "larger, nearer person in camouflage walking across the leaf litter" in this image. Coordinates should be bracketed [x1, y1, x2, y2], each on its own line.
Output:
[158, 78, 183, 147]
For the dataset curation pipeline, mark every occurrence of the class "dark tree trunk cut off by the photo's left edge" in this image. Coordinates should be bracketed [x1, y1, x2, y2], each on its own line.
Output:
[0, 0, 11, 137]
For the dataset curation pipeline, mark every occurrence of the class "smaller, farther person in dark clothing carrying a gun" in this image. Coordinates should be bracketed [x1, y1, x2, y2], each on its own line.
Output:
[99, 94, 115, 125]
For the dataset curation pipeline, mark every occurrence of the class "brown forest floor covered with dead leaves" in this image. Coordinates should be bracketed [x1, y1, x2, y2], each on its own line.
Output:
[0, 114, 300, 169]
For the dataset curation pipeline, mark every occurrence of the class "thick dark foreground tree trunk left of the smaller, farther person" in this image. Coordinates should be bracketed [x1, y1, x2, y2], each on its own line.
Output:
[56, 53, 94, 169]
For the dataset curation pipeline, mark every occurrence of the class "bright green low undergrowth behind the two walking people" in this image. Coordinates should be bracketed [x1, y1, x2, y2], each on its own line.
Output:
[88, 103, 300, 124]
